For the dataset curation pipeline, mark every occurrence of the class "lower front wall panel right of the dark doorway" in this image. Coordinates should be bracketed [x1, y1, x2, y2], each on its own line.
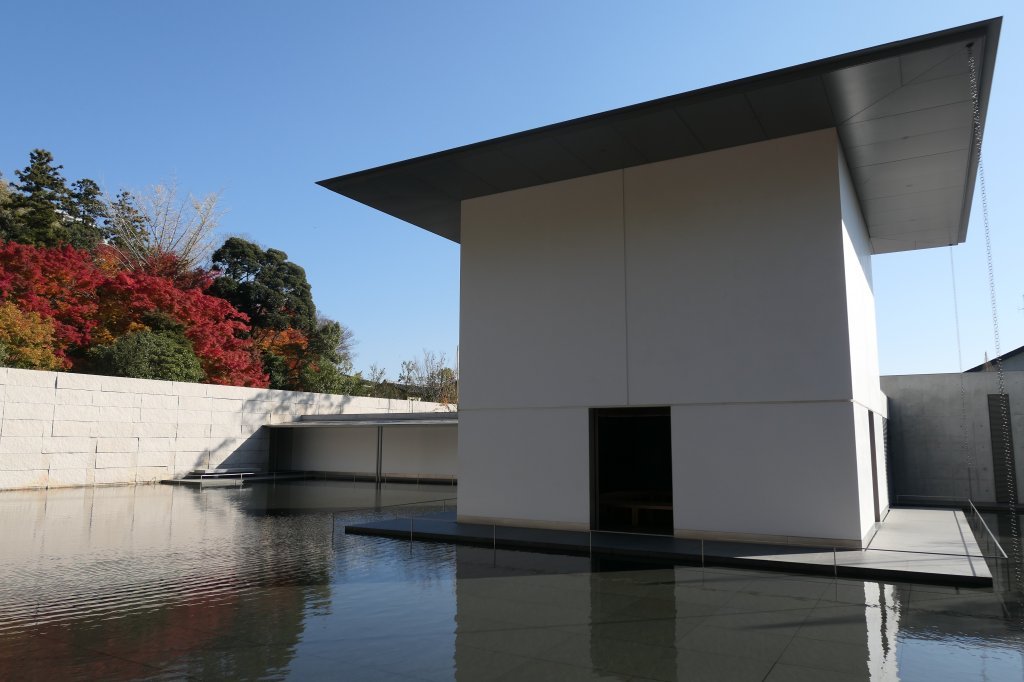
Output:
[672, 401, 861, 543]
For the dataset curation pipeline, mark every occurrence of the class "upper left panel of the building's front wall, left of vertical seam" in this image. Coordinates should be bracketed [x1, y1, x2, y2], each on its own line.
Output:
[459, 172, 627, 410]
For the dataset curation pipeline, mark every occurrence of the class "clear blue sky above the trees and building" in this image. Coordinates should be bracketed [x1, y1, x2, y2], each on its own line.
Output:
[0, 0, 1024, 377]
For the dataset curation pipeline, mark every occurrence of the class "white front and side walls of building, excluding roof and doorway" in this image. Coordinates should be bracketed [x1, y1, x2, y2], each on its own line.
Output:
[459, 130, 884, 543]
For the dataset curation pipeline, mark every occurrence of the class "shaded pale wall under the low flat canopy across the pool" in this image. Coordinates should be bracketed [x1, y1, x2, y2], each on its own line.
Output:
[279, 424, 459, 478]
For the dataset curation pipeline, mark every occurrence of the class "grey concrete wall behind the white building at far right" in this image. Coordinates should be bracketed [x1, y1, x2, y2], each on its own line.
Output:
[882, 372, 1024, 504]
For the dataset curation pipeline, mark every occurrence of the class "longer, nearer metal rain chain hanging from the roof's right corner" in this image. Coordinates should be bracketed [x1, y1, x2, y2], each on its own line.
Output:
[967, 45, 1024, 593]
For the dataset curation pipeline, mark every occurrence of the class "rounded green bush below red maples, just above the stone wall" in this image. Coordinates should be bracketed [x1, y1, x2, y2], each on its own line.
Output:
[89, 330, 206, 382]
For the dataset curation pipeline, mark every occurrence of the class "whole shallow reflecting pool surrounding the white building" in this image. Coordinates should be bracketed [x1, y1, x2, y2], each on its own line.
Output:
[0, 481, 1024, 681]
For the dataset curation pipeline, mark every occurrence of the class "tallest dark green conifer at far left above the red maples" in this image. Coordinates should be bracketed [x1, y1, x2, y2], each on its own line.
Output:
[0, 150, 106, 249]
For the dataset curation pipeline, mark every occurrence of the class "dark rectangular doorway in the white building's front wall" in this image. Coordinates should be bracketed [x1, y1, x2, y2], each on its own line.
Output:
[590, 408, 673, 535]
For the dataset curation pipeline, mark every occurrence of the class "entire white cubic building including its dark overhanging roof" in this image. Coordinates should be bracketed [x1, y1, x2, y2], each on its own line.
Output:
[322, 19, 1000, 547]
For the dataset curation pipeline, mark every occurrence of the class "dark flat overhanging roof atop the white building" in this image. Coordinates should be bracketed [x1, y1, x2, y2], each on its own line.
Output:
[318, 18, 1002, 253]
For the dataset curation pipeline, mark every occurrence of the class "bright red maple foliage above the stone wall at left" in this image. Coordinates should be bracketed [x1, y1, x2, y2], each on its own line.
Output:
[0, 243, 268, 387]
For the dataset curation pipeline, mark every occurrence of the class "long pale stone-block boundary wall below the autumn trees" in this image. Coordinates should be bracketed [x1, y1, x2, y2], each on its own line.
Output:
[0, 368, 448, 489]
